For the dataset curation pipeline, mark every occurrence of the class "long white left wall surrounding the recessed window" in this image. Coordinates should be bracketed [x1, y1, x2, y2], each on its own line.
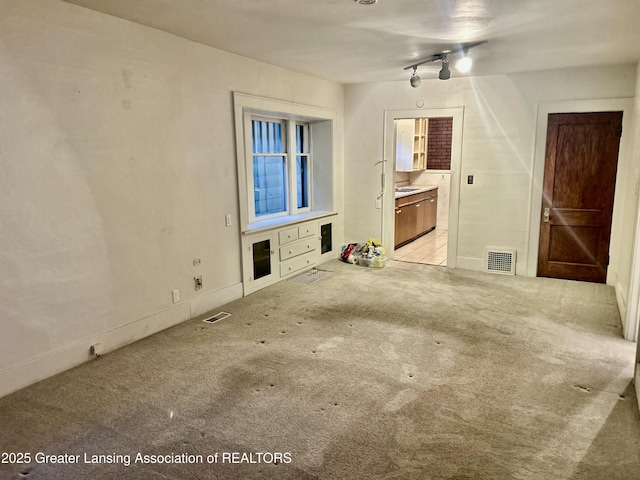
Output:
[0, 0, 344, 396]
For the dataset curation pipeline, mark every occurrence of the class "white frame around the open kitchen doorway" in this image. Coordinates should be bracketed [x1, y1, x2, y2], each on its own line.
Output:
[381, 107, 464, 268]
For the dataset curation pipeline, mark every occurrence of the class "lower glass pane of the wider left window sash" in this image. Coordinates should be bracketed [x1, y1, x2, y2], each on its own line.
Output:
[253, 156, 287, 217]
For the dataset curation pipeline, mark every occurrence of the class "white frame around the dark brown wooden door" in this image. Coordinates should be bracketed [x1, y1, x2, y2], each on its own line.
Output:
[526, 98, 637, 330]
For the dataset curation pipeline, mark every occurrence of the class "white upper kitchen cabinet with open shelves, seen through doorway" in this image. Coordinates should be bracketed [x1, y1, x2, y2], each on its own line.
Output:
[396, 118, 429, 172]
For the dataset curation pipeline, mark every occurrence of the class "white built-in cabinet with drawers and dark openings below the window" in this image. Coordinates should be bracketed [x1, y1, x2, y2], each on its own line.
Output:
[242, 219, 333, 295]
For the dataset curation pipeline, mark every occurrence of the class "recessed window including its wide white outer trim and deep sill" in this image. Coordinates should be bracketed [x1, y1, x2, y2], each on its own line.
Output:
[234, 92, 337, 232]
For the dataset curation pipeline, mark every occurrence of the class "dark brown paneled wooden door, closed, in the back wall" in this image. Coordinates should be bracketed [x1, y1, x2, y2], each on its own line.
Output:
[538, 112, 622, 283]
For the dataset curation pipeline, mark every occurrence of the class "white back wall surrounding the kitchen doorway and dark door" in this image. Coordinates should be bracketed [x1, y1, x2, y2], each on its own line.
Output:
[345, 65, 636, 275]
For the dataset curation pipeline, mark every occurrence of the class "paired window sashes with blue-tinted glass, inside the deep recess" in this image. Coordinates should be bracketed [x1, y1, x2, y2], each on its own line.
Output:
[250, 115, 311, 221]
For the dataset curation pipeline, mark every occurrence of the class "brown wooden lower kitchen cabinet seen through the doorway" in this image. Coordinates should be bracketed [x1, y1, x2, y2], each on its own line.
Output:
[394, 188, 438, 248]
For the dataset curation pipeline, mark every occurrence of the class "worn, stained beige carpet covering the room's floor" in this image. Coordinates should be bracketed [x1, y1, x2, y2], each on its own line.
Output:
[0, 261, 640, 480]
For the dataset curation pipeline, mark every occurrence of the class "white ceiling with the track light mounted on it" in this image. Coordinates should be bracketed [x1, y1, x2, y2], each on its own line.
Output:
[65, 0, 640, 84]
